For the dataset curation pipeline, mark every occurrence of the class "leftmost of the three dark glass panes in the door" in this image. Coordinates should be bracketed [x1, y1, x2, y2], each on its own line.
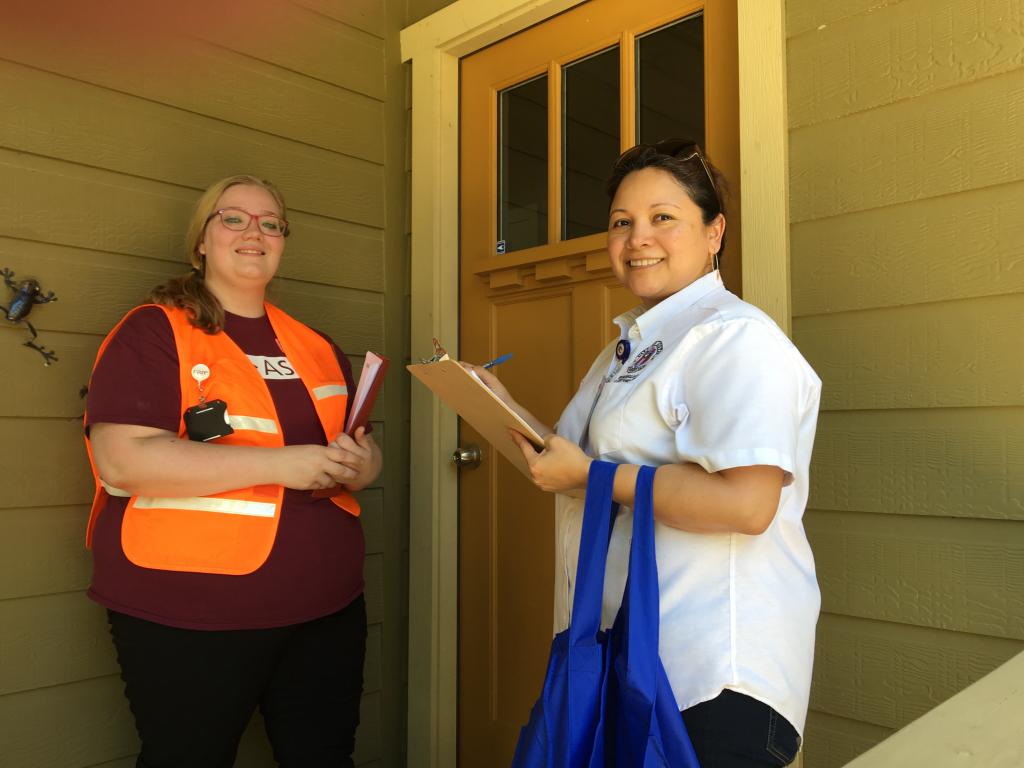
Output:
[496, 75, 548, 253]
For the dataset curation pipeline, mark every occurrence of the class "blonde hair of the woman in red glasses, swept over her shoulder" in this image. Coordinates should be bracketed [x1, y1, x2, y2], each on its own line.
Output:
[148, 174, 288, 334]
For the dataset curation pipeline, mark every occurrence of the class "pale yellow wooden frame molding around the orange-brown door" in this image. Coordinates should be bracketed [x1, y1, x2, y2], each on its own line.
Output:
[399, 0, 791, 768]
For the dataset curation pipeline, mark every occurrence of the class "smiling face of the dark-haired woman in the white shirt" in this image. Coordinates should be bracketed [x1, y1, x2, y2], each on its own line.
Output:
[608, 168, 725, 308]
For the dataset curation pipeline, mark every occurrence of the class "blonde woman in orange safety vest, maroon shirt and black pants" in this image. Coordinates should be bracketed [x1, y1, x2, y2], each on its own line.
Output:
[86, 176, 381, 768]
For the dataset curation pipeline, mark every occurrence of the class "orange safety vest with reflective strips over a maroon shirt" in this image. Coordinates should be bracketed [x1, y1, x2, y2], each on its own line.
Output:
[85, 304, 359, 574]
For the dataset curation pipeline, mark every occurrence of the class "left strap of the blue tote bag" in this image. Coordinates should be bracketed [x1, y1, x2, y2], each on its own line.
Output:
[569, 460, 618, 646]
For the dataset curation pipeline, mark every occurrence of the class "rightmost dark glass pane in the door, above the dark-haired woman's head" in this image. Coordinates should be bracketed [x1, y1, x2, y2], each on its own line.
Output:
[636, 13, 705, 146]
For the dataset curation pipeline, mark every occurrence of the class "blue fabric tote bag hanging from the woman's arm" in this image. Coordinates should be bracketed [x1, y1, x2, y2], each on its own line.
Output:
[512, 461, 699, 768]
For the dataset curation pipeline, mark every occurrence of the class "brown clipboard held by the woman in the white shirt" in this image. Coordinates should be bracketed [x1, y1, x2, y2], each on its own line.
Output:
[406, 355, 544, 477]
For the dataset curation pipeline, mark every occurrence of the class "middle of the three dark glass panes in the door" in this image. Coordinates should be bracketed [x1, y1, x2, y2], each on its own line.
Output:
[562, 46, 620, 240]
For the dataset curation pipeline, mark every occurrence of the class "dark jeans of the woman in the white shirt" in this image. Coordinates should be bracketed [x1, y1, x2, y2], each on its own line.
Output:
[683, 689, 800, 768]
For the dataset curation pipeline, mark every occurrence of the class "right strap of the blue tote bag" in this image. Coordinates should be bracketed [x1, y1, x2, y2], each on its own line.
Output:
[622, 467, 660, 700]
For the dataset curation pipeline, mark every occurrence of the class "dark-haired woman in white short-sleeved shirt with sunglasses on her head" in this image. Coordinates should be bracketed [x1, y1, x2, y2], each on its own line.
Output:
[470, 140, 820, 768]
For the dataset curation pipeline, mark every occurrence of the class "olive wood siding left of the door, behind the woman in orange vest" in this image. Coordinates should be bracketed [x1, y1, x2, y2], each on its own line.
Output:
[0, 0, 408, 768]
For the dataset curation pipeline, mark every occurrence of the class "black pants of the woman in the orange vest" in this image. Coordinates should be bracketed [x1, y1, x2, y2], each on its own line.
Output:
[108, 596, 367, 768]
